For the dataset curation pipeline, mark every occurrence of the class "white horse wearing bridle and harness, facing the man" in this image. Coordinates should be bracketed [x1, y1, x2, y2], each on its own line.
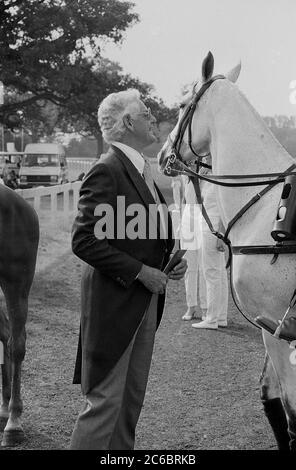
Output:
[159, 53, 296, 450]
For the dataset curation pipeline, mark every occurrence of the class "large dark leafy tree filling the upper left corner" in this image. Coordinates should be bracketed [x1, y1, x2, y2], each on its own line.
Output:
[0, 0, 138, 128]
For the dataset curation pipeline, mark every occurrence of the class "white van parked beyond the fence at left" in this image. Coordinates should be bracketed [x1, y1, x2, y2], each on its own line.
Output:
[19, 143, 69, 188]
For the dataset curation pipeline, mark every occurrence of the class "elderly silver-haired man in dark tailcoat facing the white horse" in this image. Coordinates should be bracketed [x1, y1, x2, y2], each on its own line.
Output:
[71, 90, 186, 450]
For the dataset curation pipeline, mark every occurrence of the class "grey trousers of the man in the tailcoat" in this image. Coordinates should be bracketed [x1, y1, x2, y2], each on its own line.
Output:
[70, 295, 158, 450]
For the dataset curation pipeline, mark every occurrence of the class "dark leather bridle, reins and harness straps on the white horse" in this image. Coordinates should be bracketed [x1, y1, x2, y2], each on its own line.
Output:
[162, 75, 296, 329]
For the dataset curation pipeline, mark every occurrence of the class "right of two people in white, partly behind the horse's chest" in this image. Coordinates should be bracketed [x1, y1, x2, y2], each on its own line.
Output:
[192, 160, 228, 329]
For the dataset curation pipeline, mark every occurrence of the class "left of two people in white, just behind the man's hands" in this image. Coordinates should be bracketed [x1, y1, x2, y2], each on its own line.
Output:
[172, 176, 207, 320]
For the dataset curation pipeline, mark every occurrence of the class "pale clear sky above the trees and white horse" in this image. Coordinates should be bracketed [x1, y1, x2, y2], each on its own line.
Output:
[103, 0, 296, 116]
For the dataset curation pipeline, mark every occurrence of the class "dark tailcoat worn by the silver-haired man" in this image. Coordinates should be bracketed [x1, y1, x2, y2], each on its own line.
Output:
[72, 147, 174, 394]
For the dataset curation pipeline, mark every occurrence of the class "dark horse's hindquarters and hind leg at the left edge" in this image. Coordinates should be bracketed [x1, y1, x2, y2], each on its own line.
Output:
[0, 185, 39, 446]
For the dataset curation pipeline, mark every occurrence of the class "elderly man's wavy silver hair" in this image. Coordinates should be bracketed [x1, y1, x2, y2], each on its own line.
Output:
[98, 88, 141, 144]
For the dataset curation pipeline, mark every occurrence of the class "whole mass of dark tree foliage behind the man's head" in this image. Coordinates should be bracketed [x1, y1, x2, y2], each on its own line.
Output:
[0, 0, 175, 152]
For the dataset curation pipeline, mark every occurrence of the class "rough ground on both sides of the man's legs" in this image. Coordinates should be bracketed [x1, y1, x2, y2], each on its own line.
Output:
[0, 209, 276, 451]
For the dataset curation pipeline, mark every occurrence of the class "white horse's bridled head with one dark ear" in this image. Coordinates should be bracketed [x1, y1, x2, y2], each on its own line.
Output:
[158, 52, 241, 176]
